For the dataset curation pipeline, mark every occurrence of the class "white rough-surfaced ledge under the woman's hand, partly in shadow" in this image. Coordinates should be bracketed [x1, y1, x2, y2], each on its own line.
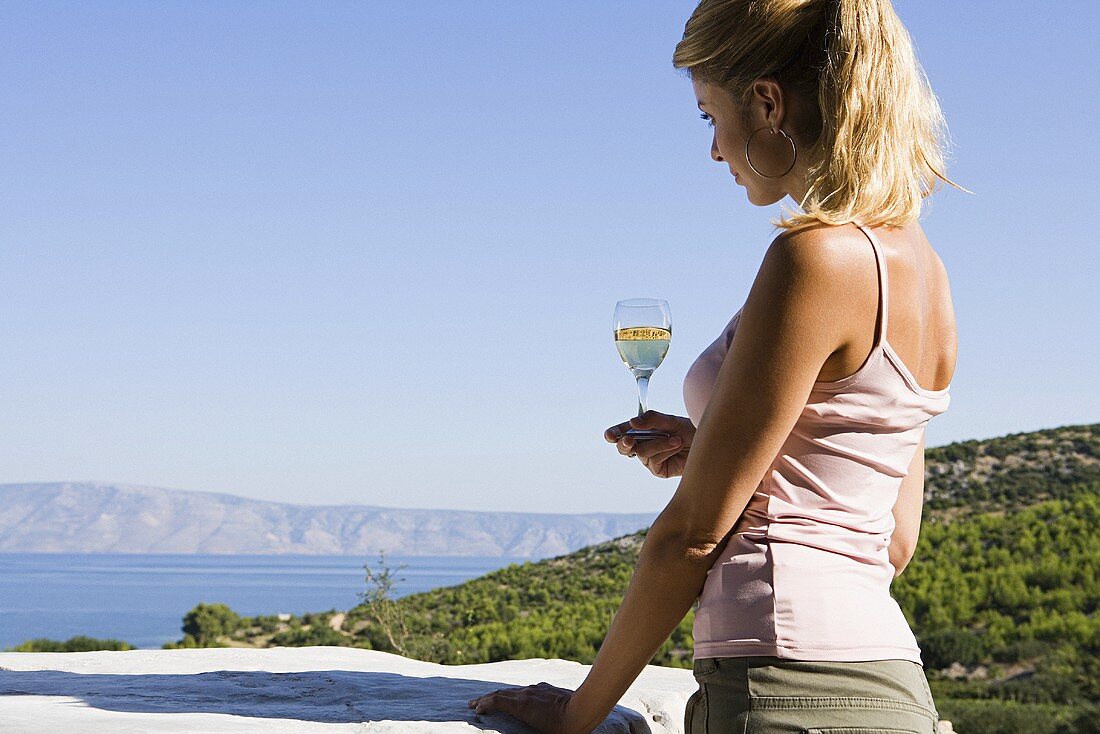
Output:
[0, 647, 695, 734]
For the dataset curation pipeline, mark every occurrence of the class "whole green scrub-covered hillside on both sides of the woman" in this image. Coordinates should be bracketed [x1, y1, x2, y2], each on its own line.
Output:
[165, 424, 1100, 734]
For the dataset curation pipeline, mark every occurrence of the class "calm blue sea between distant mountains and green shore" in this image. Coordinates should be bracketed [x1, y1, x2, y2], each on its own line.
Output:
[0, 552, 529, 650]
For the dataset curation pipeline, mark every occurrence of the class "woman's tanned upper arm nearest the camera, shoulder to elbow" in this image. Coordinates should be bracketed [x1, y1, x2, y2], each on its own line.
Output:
[653, 230, 850, 556]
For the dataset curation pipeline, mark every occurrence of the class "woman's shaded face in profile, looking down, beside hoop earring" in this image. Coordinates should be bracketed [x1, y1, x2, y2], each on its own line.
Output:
[692, 81, 798, 206]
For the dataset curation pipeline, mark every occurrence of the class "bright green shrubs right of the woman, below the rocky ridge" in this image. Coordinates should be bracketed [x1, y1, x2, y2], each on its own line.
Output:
[893, 490, 1100, 734]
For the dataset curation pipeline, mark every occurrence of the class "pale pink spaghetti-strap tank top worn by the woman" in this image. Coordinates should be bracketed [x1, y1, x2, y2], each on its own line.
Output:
[684, 227, 950, 664]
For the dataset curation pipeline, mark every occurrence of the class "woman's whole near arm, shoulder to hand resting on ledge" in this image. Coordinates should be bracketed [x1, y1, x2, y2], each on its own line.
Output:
[474, 230, 850, 734]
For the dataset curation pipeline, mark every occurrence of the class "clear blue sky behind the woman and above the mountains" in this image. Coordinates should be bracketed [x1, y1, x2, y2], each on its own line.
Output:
[0, 0, 1100, 512]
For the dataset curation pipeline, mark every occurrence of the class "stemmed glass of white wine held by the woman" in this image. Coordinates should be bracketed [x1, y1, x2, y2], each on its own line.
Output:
[615, 298, 672, 441]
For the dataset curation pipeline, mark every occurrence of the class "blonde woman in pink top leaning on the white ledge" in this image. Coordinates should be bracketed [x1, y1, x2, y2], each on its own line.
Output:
[470, 0, 956, 734]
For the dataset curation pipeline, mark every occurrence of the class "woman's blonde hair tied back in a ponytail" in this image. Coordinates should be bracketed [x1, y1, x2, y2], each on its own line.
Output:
[672, 0, 955, 229]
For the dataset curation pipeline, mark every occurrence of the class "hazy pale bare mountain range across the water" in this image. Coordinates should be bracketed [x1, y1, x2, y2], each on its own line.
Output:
[0, 482, 653, 558]
